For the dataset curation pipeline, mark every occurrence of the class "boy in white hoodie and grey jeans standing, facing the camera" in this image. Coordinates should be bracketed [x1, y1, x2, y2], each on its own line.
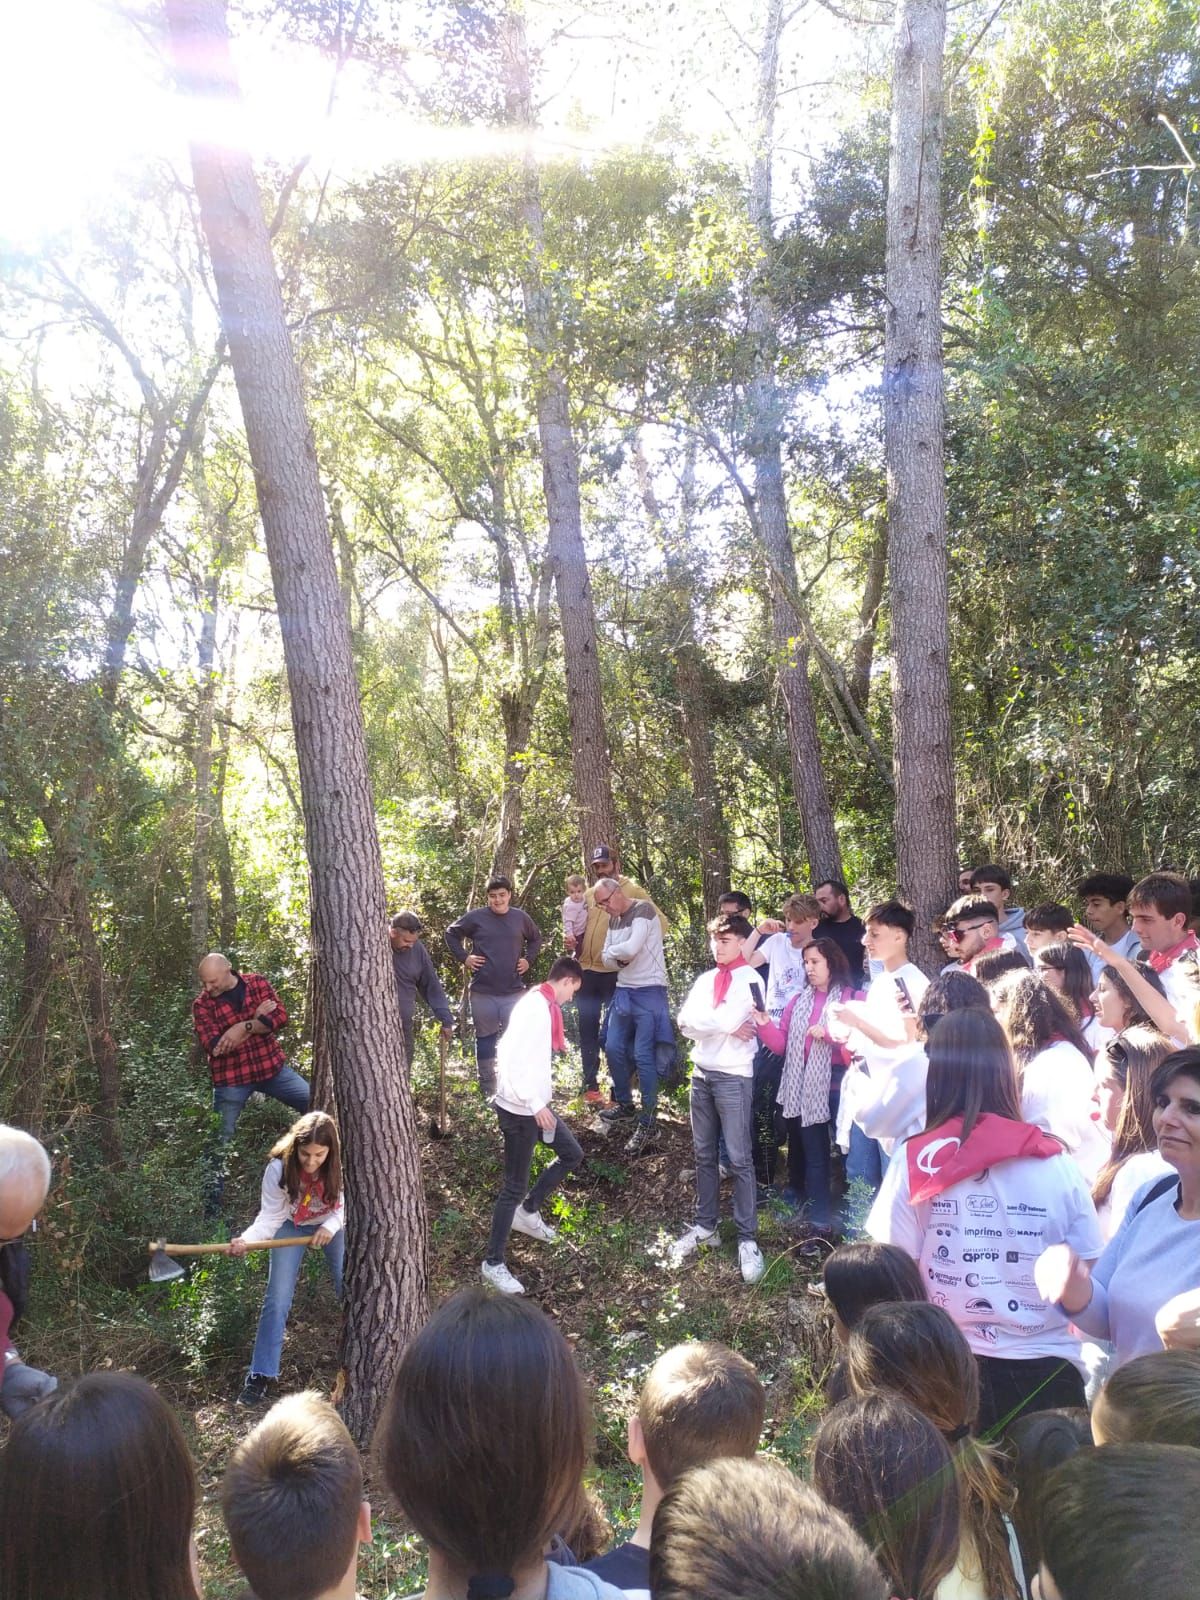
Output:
[667, 917, 766, 1283]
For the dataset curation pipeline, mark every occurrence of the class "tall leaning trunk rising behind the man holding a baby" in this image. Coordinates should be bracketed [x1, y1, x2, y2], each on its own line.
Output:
[501, 11, 618, 854]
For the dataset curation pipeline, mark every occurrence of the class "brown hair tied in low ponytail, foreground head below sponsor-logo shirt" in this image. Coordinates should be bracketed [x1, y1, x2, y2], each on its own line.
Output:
[846, 1299, 1021, 1600]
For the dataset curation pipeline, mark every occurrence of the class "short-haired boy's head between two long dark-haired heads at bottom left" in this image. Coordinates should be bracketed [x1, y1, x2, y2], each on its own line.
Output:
[221, 1394, 363, 1600]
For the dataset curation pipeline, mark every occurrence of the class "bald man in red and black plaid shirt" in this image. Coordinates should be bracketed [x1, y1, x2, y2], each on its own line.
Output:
[192, 952, 309, 1142]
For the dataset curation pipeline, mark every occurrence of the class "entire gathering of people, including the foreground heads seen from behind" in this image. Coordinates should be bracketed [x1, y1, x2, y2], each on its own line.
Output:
[0, 846, 1200, 1600]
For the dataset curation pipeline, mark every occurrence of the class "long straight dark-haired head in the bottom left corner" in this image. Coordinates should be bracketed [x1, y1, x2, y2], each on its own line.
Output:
[0, 1373, 195, 1600]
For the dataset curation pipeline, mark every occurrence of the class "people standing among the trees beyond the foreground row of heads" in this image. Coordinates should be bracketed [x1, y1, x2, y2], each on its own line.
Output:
[178, 845, 1200, 1430]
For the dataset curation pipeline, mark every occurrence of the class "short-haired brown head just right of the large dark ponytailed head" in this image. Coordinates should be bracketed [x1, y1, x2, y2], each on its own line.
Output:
[637, 1342, 766, 1490]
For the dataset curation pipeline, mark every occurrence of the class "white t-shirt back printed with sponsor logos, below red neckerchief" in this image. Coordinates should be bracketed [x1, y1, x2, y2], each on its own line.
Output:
[867, 1146, 1102, 1371]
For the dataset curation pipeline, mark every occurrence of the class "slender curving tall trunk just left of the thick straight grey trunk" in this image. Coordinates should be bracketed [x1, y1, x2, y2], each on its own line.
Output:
[746, 0, 842, 883]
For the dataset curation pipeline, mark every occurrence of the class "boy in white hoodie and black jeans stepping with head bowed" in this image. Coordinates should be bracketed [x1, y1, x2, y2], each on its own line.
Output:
[480, 955, 584, 1294]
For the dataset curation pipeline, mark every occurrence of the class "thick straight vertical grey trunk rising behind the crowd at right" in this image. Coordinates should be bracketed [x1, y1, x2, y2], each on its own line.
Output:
[883, 0, 957, 965]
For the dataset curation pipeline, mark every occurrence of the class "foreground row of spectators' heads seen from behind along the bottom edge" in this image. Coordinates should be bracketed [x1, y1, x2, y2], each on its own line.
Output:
[0, 1280, 1200, 1600]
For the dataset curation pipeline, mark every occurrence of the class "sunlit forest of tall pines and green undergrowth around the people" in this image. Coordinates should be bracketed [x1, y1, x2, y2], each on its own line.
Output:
[0, 0, 1200, 1595]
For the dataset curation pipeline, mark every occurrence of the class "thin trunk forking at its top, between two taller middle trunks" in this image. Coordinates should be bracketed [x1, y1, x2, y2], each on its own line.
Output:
[634, 435, 730, 918]
